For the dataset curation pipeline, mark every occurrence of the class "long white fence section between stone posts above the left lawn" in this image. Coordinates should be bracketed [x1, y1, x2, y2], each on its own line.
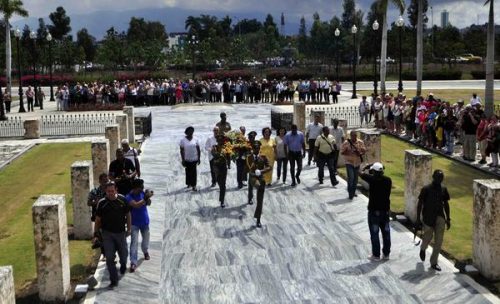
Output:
[40, 113, 116, 136]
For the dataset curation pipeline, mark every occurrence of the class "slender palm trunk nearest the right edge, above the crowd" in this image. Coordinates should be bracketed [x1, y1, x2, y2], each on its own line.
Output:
[484, 0, 495, 117]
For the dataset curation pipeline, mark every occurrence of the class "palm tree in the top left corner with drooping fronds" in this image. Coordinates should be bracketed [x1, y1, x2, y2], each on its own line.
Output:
[0, 0, 28, 97]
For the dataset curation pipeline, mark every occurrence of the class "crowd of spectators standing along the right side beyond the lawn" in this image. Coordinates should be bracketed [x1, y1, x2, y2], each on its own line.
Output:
[358, 93, 500, 168]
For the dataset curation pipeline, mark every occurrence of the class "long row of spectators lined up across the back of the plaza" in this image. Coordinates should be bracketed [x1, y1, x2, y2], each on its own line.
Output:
[47, 77, 348, 111]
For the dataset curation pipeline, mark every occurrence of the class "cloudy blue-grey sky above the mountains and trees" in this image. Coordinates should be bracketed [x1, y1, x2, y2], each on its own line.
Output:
[9, 0, 494, 28]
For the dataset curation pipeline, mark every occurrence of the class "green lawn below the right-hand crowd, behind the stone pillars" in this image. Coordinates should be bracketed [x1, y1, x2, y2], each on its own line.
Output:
[382, 136, 493, 260]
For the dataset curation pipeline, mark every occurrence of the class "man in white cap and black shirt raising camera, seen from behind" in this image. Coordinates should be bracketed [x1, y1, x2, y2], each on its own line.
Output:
[360, 162, 392, 261]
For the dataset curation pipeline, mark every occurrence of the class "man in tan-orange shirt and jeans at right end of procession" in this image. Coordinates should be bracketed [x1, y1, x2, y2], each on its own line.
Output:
[340, 130, 366, 200]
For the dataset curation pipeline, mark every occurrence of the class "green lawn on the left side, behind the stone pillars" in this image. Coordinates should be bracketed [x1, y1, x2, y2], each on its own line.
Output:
[0, 143, 94, 291]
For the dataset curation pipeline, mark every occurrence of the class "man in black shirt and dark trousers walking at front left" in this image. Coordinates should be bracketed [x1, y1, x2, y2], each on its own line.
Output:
[94, 182, 132, 288]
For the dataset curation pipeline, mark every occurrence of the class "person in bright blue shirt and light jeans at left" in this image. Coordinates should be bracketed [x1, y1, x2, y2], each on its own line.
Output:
[125, 179, 153, 272]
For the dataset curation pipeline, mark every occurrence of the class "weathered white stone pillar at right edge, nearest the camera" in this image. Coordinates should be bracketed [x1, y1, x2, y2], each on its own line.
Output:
[472, 179, 500, 280]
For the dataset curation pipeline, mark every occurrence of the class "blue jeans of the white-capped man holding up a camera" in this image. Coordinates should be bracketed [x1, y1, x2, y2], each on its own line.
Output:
[368, 211, 391, 257]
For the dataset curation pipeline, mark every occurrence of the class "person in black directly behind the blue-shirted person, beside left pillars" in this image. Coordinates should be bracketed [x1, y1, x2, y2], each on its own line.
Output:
[109, 148, 137, 195]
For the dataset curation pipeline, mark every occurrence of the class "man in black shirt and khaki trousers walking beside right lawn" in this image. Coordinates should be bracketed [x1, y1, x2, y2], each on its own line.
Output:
[417, 170, 451, 271]
